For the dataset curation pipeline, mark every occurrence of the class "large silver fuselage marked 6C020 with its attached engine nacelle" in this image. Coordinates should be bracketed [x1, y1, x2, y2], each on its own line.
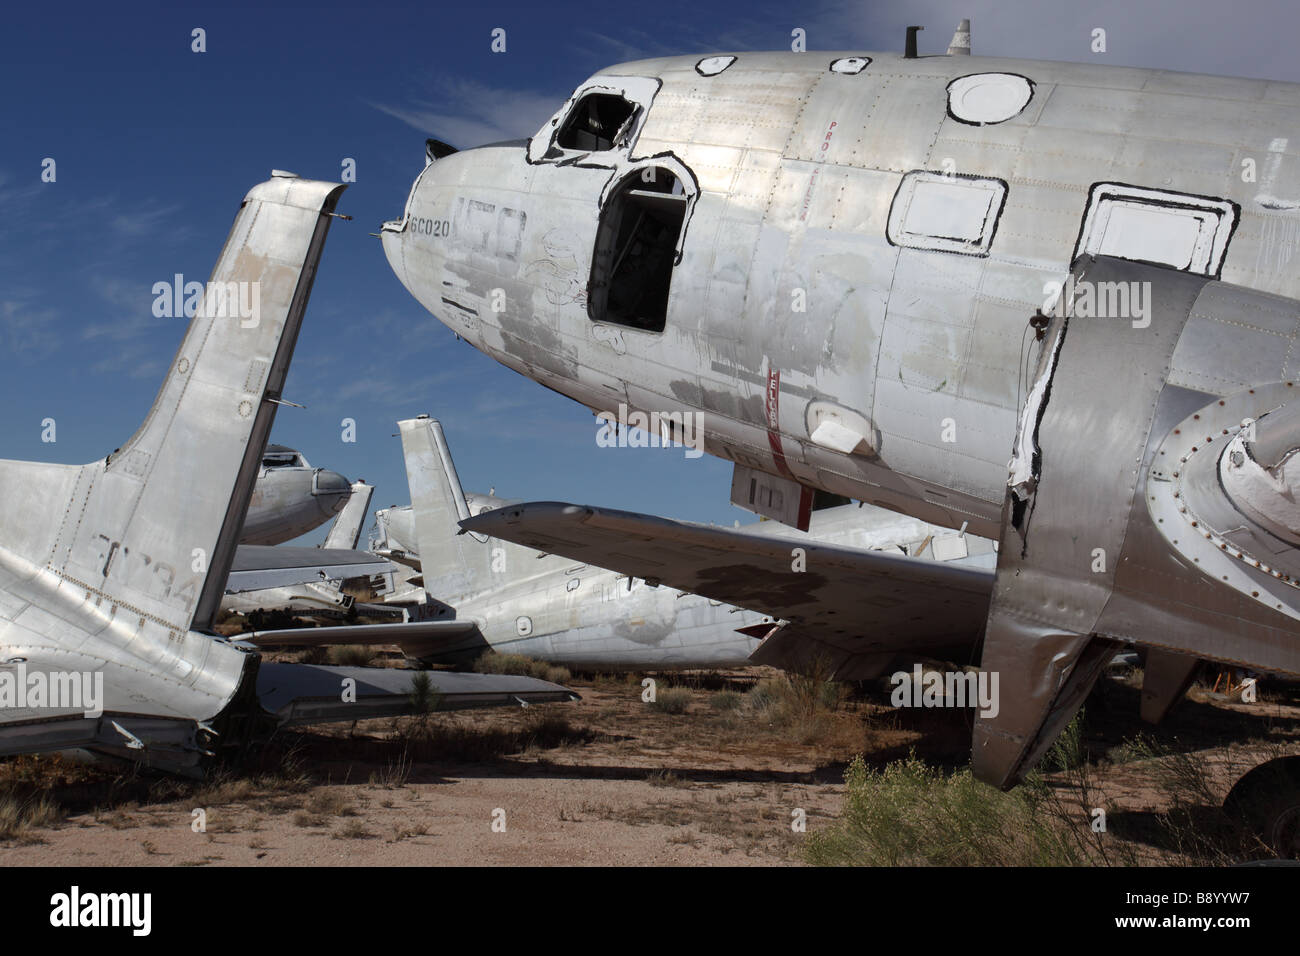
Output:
[382, 33, 1300, 787]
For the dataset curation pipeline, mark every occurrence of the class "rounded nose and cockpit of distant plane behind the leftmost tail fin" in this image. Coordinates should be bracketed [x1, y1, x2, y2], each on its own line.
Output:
[241, 445, 352, 545]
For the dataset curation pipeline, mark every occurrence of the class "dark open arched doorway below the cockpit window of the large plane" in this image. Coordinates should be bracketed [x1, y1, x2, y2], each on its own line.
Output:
[588, 166, 688, 332]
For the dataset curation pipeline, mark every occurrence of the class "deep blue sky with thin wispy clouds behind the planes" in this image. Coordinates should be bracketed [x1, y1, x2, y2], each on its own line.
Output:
[0, 0, 1300, 537]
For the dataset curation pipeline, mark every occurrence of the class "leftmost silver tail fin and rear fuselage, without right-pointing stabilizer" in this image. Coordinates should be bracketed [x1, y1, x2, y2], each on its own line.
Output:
[0, 176, 345, 752]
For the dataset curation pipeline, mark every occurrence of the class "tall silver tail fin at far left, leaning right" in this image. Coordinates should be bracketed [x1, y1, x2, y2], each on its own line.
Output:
[0, 174, 345, 639]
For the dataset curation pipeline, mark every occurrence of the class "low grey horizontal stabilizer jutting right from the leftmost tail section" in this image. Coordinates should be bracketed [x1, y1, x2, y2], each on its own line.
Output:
[257, 660, 579, 726]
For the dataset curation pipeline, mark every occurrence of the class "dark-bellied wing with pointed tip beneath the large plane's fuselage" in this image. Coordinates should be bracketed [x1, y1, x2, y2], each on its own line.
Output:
[460, 502, 993, 680]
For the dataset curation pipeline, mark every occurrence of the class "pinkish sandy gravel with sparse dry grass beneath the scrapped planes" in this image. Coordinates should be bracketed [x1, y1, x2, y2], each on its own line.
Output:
[0, 672, 1300, 866]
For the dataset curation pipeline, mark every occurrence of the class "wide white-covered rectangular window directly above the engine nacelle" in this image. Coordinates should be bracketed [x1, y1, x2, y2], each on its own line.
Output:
[1075, 182, 1238, 276]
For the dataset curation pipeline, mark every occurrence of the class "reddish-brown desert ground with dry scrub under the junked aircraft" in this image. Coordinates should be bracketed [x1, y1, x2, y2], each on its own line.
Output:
[0, 658, 1300, 866]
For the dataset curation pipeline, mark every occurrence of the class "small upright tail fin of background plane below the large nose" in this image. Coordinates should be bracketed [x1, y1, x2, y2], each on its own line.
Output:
[398, 415, 542, 604]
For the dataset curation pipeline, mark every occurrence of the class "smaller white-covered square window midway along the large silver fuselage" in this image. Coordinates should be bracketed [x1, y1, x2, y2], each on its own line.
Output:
[887, 170, 1006, 256]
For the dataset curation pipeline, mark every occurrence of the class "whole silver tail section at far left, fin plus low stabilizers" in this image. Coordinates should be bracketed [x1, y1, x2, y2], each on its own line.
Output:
[0, 172, 572, 774]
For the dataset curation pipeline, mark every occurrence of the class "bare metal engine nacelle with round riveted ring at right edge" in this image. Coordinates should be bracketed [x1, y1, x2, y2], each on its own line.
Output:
[972, 256, 1300, 787]
